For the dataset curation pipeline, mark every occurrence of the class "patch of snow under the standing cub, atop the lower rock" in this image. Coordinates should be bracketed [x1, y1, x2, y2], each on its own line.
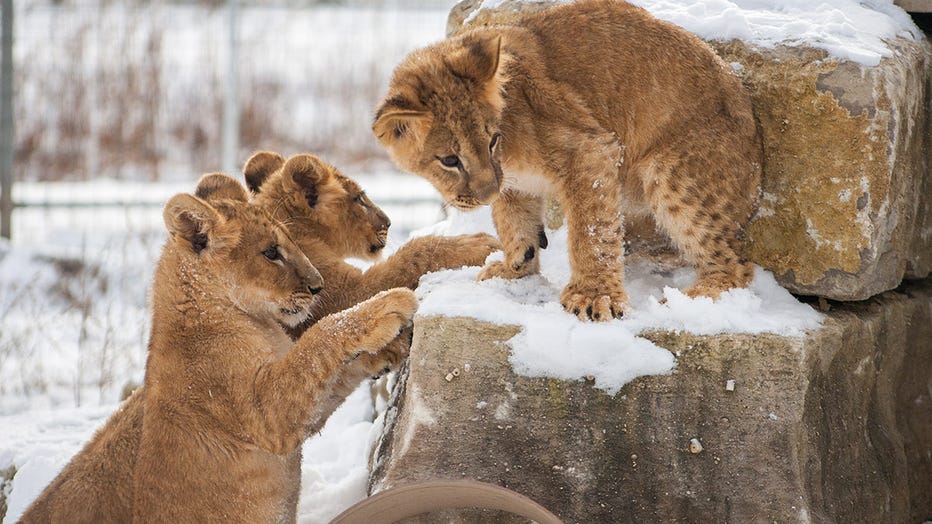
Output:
[415, 209, 822, 394]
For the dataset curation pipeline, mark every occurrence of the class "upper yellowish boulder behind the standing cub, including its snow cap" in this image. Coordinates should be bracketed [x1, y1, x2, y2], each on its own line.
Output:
[447, 0, 932, 300]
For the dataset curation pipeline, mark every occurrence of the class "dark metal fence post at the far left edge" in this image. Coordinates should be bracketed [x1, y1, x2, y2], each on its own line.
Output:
[0, 0, 13, 238]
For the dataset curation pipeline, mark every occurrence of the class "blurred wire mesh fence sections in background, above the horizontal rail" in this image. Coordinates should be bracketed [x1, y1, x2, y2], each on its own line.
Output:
[14, 0, 449, 181]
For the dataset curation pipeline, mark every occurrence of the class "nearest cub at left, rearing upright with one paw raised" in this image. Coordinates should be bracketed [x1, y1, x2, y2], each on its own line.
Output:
[133, 175, 417, 522]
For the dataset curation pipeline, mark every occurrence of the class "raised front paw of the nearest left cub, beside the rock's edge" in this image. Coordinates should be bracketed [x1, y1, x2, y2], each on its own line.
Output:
[357, 288, 418, 353]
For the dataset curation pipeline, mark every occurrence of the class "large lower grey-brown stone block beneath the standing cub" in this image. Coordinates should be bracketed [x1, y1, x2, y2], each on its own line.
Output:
[371, 281, 932, 523]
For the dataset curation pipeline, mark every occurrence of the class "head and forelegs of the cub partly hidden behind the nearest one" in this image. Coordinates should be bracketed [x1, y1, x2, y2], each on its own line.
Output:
[243, 151, 500, 519]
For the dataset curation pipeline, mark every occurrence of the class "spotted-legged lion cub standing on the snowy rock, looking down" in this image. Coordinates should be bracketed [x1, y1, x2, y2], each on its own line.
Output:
[373, 0, 762, 320]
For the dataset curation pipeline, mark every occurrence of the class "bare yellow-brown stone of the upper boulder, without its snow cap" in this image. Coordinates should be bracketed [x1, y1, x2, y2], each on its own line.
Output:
[447, 0, 932, 300]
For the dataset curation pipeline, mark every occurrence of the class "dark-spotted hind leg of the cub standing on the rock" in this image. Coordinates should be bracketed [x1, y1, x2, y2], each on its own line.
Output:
[644, 143, 760, 299]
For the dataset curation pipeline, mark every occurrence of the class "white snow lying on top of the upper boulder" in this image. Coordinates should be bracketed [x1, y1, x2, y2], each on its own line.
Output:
[473, 0, 922, 66]
